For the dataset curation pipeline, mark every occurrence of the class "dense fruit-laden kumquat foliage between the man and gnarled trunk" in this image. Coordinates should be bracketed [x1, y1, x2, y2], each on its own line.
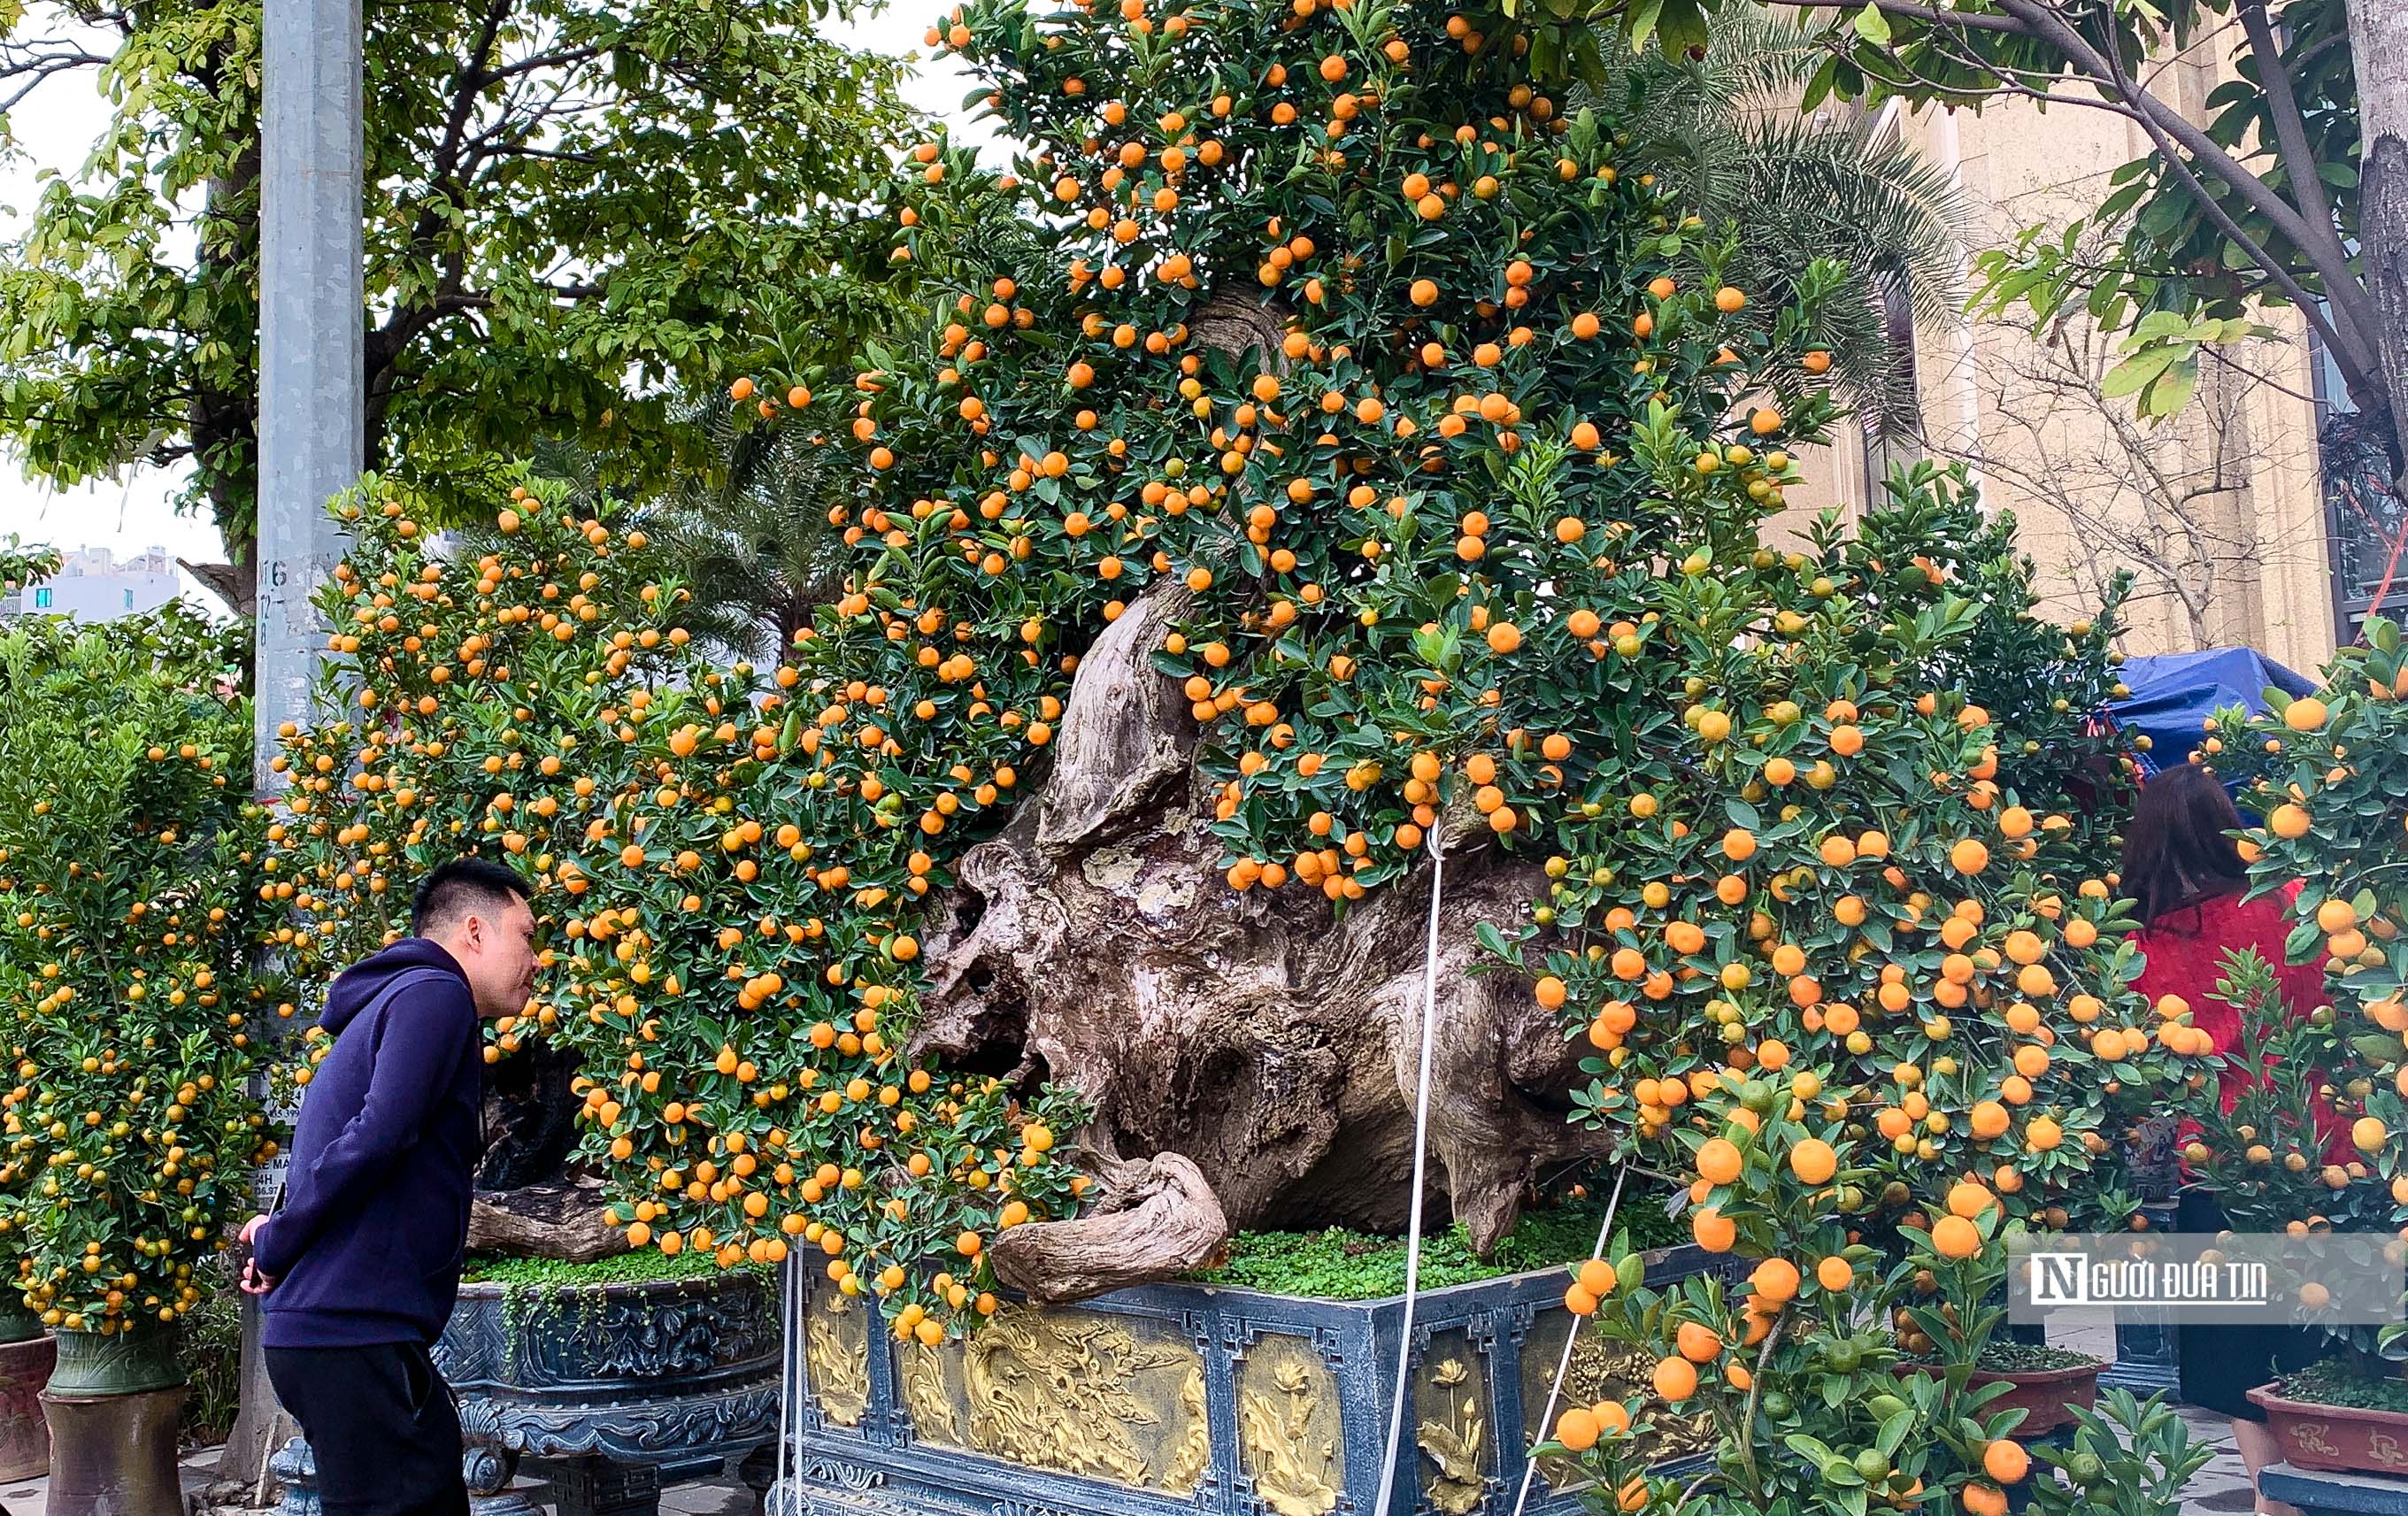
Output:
[258, 486, 1086, 1338]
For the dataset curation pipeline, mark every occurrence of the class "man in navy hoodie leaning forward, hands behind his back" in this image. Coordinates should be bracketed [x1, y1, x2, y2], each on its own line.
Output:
[243, 859, 535, 1516]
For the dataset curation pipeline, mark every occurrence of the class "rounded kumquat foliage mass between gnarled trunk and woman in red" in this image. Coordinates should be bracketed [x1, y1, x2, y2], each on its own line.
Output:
[1517, 465, 2205, 1239]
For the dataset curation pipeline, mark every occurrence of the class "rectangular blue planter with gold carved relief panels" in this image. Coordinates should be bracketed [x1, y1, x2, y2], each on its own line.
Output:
[771, 1246, 1729, 1516]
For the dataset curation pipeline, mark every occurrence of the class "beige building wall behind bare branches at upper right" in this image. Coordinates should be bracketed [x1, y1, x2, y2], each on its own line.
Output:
[1791, 75, 2369, 672]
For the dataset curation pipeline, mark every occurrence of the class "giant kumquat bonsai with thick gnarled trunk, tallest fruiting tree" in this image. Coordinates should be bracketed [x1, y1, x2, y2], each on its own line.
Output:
[683, 3, 2198, 1288]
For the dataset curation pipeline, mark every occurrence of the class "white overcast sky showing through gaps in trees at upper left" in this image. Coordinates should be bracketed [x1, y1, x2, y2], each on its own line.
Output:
[0, 0, 985, 596]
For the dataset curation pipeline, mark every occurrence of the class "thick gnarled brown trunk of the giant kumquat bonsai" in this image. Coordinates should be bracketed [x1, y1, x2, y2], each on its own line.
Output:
[919, 587, 1594, 1295]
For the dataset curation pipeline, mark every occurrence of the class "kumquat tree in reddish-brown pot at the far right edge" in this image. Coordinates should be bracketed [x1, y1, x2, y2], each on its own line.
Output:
[2187, 616, 2408, 1475]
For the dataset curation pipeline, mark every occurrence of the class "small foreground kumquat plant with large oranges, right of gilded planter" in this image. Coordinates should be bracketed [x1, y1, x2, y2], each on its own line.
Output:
[1541, 1075, 2208, 1516]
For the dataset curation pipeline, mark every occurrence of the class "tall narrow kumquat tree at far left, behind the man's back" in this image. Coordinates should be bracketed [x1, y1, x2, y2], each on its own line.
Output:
[0, 606, 291, 1389]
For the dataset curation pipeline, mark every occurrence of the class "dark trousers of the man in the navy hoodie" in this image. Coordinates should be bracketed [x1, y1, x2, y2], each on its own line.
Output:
[267, 1343, 467, 1516]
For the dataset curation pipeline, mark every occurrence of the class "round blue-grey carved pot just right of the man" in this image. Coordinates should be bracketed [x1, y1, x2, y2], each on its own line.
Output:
[434, 1271, 781, 1516]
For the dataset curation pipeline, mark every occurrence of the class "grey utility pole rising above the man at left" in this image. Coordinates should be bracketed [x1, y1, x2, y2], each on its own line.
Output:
[255, 0, 366, 789]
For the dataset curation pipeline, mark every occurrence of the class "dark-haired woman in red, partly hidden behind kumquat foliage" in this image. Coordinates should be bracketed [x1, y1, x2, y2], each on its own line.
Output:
[2121, 763, 2348, 1516]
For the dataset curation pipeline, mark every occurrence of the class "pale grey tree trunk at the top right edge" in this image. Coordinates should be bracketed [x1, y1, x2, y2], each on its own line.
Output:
[2350, 0, 2408, 489]
